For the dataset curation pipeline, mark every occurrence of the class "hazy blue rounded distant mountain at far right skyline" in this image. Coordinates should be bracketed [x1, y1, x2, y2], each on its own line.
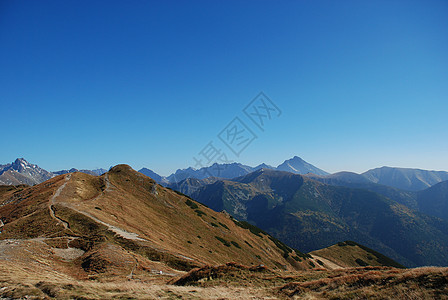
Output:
[361, 167, 448, 191]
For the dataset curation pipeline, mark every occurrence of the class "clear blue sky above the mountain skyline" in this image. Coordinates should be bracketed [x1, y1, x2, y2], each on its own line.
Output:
[0, 0, 448, 175]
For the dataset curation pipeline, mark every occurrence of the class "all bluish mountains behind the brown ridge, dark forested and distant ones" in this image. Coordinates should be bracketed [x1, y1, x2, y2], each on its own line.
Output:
[0, 157, 448, 266]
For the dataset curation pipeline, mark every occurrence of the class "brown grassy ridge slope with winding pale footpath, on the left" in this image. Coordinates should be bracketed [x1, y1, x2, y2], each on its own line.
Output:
[0, 165, 316, 277]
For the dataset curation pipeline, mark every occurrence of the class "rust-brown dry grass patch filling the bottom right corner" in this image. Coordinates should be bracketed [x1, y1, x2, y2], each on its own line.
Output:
[279, 267, 448, 299]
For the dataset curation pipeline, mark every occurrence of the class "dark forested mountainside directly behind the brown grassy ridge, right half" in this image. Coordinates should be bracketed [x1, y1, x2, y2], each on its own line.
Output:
[193, 170, 448, 266]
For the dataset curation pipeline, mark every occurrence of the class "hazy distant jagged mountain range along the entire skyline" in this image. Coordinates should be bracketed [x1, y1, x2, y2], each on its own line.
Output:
[0, 156, 448, 192]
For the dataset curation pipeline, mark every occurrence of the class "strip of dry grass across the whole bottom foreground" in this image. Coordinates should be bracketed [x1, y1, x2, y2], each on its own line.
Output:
[0, 263, 448, 299]
